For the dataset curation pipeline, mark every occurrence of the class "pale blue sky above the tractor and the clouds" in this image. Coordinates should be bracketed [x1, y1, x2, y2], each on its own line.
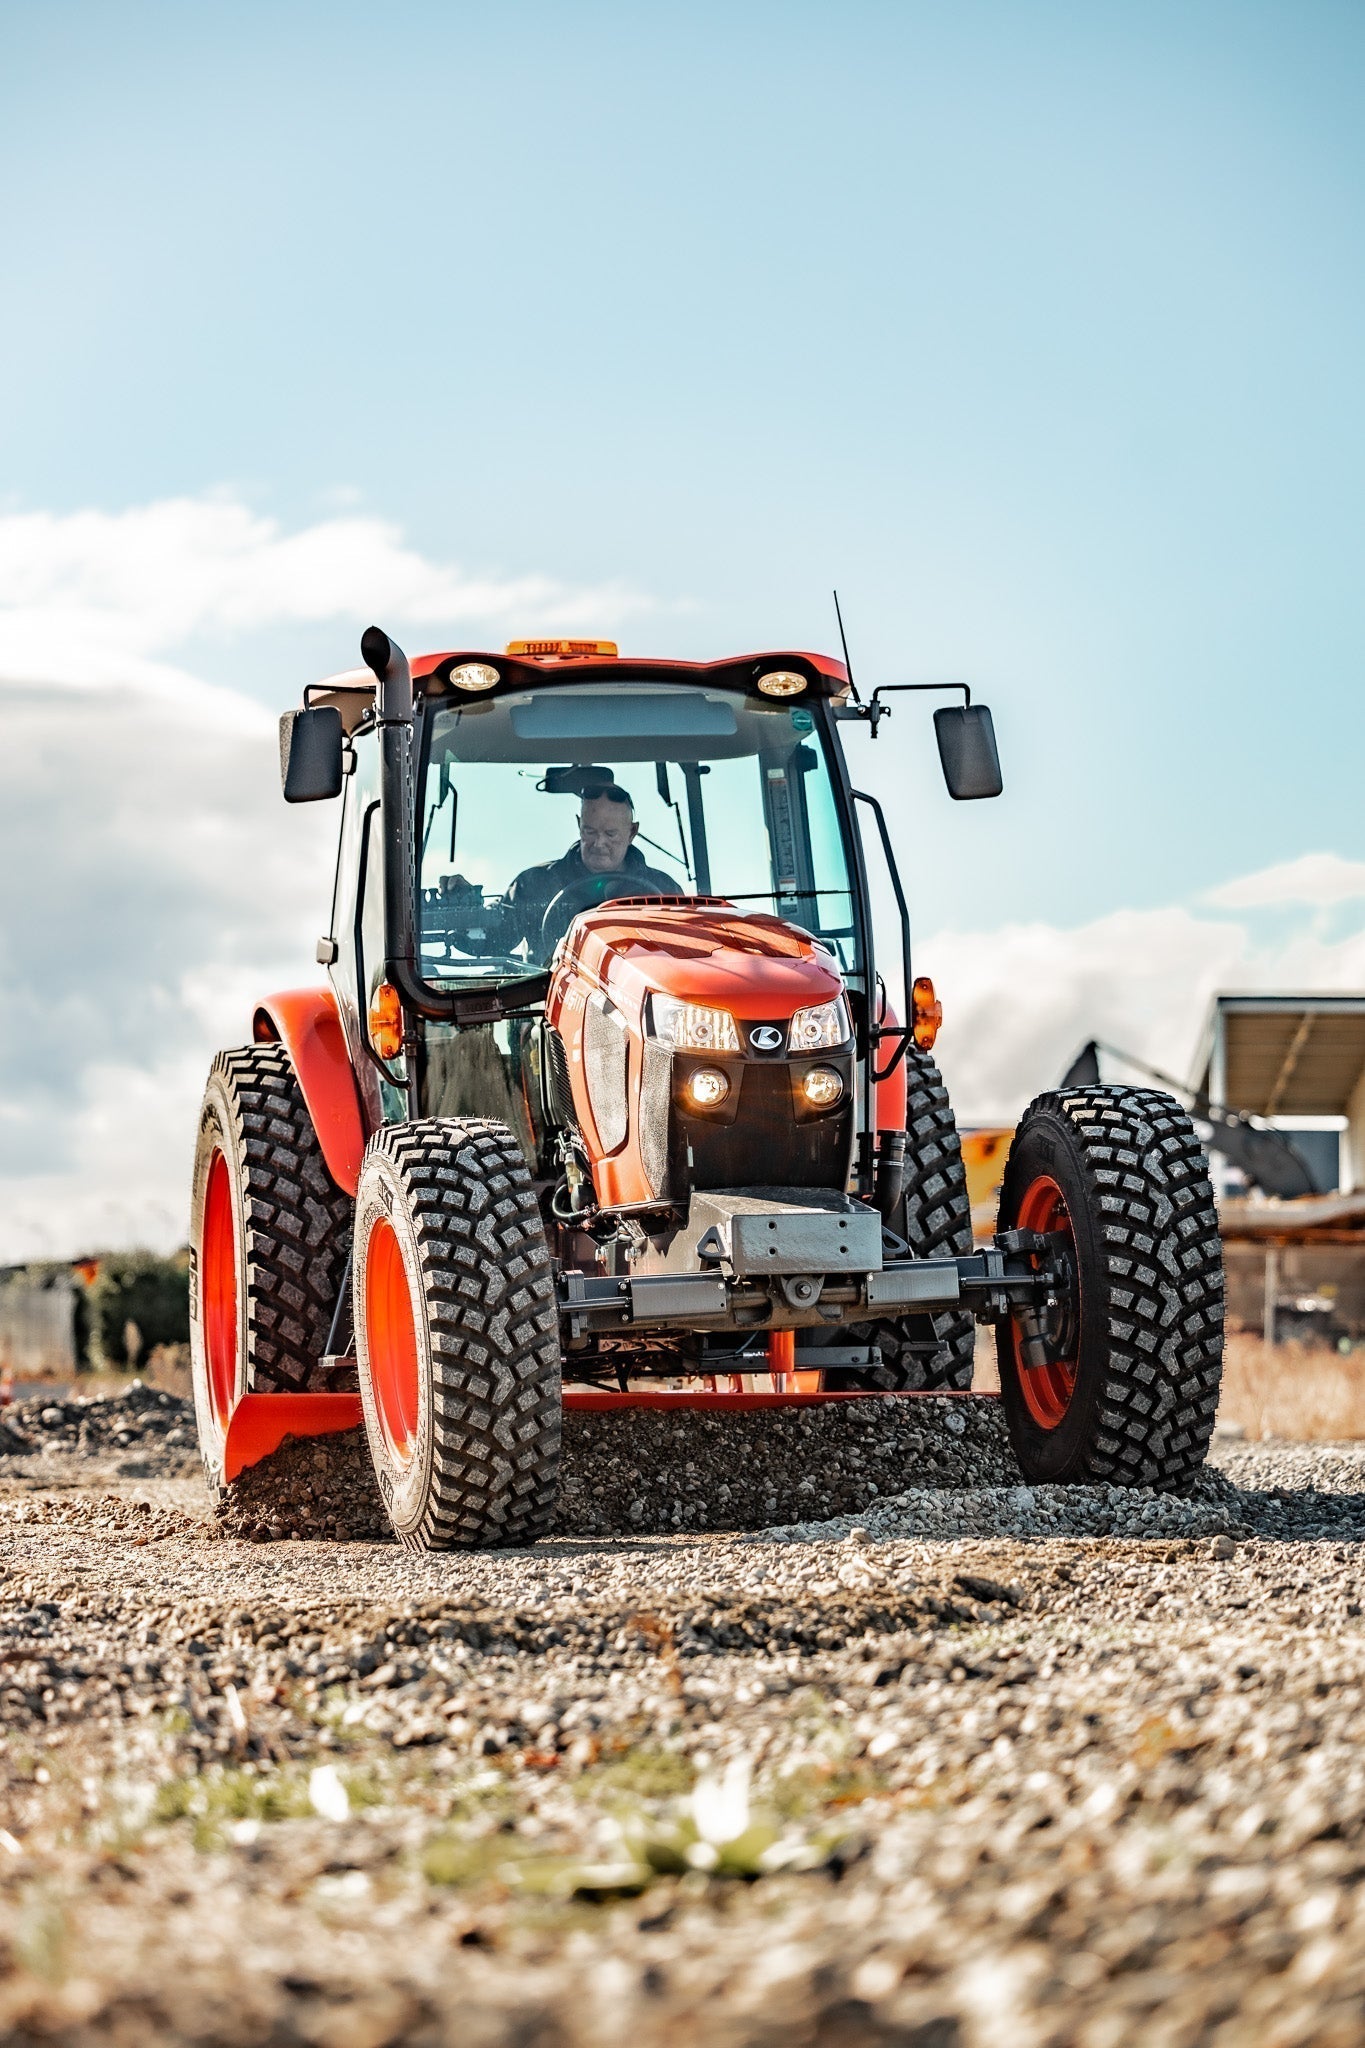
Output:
[0, 0, 1365, 1257]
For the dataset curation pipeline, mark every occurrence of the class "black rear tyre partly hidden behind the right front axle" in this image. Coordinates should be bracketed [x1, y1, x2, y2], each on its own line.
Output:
[822, 1047, 976, 1393]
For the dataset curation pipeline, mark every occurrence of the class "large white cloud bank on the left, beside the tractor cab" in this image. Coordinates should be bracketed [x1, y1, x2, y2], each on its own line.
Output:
[0, 494, 645, 1262]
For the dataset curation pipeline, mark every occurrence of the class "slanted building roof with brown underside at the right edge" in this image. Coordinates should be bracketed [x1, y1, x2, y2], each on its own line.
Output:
[1193, 995, 1365, 1116]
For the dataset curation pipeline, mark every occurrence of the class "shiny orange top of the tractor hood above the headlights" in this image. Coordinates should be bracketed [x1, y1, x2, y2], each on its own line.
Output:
[548, 897, 843, 1024]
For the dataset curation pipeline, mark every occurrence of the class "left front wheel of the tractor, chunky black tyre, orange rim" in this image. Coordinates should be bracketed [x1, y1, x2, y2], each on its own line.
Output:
[354, 1118, 561, 1550]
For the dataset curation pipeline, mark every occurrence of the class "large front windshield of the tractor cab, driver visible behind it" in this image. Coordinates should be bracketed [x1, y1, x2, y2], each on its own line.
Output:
[417, 678, 855, 987]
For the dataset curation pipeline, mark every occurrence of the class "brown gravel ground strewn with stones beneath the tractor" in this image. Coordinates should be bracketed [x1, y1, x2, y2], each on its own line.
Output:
[0, 1389, 1365, 2048]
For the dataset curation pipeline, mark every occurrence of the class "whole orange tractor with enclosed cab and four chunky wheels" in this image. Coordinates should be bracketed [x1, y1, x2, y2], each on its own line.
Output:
[190, 627, 1222, 1548]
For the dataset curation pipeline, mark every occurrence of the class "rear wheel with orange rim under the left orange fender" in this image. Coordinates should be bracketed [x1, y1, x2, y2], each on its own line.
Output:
[190, 1044, 354, 1485]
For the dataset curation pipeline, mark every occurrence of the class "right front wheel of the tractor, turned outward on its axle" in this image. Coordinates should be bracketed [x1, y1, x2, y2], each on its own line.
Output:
[997, 1085, 1224, 1493]
